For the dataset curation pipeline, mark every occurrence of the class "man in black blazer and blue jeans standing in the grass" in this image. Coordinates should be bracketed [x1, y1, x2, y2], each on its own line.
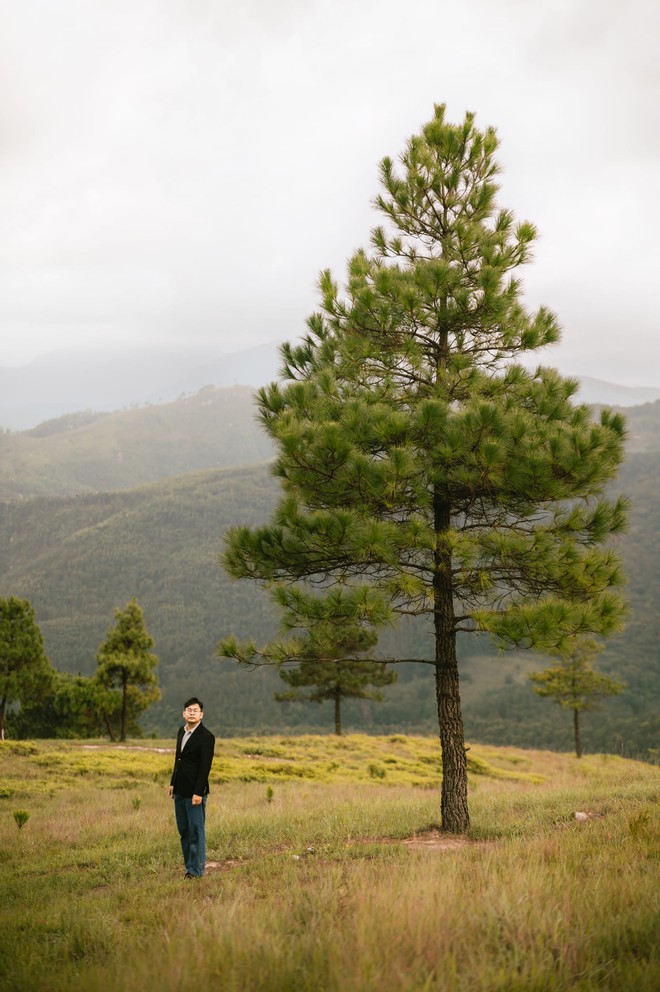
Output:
[169, 696, 215, 878]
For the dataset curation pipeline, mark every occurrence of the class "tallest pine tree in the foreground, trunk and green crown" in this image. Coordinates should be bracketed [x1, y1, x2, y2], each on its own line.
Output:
[223, 106, 626, 833]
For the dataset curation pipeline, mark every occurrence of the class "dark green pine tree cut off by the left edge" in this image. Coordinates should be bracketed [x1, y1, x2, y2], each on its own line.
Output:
[0, 596, 51, 740]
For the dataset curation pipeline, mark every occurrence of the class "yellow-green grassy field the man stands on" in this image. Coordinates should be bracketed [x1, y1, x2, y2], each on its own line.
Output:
[0, 735, 660, 992]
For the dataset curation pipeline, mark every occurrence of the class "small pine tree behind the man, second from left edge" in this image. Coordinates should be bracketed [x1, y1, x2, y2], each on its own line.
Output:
[96, 598, 160, 741]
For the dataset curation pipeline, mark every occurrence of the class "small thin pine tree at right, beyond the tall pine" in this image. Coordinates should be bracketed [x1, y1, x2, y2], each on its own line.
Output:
[529, 637, 624, 758]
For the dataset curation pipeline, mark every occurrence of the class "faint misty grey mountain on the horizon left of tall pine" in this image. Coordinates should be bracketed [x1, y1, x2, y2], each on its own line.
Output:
[0, 342, 279, 431]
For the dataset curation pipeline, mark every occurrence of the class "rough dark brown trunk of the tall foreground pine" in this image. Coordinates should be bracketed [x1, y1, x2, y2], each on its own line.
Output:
[433, 500, 470, 834]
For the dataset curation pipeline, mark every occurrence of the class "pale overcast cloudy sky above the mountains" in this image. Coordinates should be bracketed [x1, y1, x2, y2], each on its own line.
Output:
[0, 0, 660, 386]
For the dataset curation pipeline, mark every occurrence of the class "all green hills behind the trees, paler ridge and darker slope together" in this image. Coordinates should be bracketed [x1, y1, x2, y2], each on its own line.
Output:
[0, 368, 660, 755]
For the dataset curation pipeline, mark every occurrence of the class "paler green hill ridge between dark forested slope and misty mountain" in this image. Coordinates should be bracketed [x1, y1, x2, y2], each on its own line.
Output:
[0, 386, 273, 501]
